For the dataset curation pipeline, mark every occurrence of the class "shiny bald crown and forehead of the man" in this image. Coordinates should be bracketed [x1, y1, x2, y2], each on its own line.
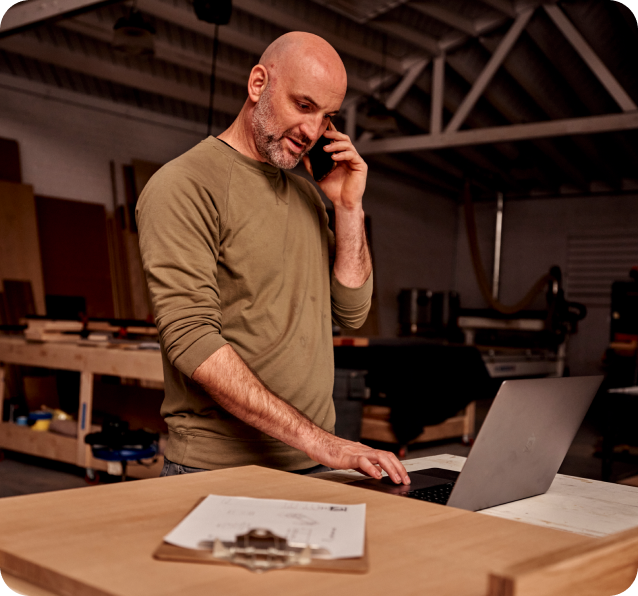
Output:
[259, 31, 348, 98]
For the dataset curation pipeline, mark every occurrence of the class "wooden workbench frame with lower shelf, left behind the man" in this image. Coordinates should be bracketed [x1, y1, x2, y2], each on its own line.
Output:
[0, 336, 164, 478]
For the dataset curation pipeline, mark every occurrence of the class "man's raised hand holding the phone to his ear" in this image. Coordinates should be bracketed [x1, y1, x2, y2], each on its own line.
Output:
[303, 122, 368, 211]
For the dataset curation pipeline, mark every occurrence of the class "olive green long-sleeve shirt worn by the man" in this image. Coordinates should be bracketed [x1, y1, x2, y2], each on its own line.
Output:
[136, 137, 372, 470]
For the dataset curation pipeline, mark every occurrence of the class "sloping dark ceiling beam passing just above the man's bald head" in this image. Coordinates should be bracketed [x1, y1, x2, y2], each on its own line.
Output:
[233, 0, 409, 75]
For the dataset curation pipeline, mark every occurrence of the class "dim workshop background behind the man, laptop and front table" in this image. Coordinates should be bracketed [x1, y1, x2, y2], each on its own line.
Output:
[0, 0, 638, 594]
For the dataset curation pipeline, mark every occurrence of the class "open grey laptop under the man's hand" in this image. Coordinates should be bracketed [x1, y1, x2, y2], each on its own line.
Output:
[349, 376, 603, 511]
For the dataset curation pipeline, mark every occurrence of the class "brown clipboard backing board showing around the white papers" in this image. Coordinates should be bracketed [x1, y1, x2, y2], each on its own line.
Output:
[153, 497, 370, 573]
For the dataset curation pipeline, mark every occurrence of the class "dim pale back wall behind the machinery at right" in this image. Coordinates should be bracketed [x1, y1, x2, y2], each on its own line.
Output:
[456, 193, 638, 375]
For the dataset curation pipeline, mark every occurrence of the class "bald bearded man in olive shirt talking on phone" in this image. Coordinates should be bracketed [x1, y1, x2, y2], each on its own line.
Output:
[137, 32, 409, 483]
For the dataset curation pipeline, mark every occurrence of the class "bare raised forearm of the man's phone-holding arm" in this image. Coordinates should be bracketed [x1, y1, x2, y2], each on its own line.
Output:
[334, 207, 372, 288]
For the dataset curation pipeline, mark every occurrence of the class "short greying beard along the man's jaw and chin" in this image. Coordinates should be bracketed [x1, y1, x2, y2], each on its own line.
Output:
[253, 85, 313, 170]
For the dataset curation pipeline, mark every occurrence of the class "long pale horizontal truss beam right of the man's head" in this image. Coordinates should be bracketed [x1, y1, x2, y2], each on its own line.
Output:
[357, 111, 638, 155]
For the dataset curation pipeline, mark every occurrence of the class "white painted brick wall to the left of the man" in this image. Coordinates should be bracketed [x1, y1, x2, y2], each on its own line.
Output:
[0, 75, 205, 210]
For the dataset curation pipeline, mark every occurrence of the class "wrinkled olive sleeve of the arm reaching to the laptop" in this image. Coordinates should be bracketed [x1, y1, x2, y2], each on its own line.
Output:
[136, 166, 227, 377]
